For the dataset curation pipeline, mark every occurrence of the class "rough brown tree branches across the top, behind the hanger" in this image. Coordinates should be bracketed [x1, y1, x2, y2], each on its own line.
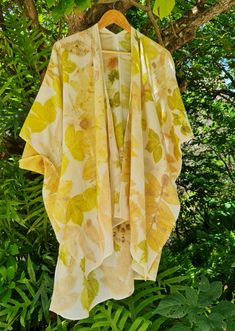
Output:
[16, 0, 235, 52]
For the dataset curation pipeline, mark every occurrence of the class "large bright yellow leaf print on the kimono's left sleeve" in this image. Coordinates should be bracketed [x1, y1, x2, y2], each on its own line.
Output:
[24, 97, 56, 132]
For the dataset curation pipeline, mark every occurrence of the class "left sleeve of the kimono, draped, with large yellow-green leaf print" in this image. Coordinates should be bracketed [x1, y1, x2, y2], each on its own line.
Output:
[19, 42, 62, 175]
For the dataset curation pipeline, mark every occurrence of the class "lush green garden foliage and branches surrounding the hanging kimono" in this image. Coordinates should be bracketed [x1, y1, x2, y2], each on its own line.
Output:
[0, 0, 235, 331]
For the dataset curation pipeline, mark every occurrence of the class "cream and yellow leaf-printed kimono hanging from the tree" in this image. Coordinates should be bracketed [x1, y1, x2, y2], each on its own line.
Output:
[19, 24, 194, 320]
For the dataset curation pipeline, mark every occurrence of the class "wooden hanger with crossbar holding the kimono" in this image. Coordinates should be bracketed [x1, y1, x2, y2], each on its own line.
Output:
[98, 9, 131, 54]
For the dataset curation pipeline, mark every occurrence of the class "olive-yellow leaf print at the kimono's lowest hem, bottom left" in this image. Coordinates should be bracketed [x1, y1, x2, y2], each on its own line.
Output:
[81, 273, 99, 310]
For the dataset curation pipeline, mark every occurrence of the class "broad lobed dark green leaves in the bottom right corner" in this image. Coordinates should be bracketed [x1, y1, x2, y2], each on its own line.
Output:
[157, 276, 235, 331]
